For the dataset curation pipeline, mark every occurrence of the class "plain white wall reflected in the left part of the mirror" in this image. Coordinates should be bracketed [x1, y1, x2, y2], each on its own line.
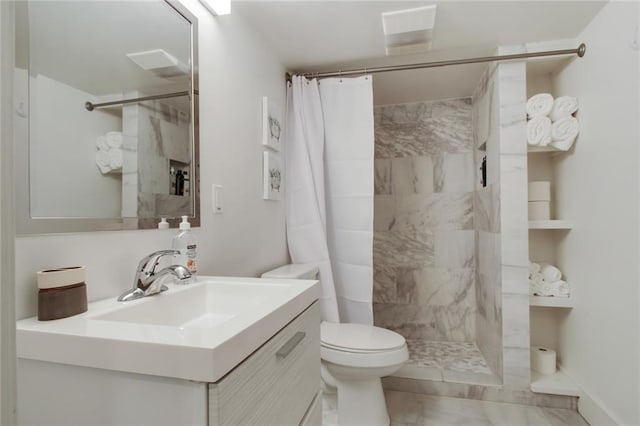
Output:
[24, 72, 122, 218]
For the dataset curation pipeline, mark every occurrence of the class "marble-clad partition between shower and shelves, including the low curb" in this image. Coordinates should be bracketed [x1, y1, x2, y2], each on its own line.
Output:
[383, 57, 544, 402]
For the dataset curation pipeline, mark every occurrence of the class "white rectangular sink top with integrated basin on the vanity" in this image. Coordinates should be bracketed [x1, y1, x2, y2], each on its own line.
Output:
[16, 277, 320, 382]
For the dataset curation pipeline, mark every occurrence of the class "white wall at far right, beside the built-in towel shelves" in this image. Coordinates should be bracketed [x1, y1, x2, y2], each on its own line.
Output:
[554, 2, 640, 425]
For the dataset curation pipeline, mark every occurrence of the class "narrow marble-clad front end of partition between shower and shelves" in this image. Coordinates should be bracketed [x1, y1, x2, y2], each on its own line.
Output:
[498, 54, 531, 389]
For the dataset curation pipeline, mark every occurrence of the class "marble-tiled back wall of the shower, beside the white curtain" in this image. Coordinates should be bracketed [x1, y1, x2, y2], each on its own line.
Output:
[373, 98, 476, 342]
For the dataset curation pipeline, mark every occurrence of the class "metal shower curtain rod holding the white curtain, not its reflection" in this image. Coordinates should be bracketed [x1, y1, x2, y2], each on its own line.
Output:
[286, 43, 587, 81]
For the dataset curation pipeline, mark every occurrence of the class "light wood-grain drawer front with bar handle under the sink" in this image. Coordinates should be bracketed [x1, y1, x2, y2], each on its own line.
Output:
[209, 302, 320, 426]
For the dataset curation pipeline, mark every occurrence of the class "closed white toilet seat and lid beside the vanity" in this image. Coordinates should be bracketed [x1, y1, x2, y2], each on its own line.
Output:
[320, 322, 409, 368]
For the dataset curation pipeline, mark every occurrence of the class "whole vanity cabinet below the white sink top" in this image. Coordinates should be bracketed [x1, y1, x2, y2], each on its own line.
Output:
[17, 301, 322, 426]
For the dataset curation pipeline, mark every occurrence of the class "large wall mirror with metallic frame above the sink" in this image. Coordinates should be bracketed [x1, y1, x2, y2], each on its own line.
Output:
[14, 0, 199, 234]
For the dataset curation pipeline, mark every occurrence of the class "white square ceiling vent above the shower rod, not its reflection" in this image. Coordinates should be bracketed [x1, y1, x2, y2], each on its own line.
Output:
[382, 4, 436, 56]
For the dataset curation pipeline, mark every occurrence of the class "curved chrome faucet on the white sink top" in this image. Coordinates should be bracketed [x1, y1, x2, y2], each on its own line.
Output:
[118, 250, 191, 302]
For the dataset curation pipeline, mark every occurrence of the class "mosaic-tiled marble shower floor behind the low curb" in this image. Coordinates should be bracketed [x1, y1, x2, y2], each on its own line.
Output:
[406, 339, 491, 374]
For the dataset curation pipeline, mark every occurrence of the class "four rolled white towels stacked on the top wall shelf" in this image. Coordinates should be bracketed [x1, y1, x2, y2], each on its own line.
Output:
[527, 93, 580, 151]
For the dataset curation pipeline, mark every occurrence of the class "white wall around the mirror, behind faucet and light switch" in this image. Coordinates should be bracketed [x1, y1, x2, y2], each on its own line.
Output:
[16, 0, 288, 318]
